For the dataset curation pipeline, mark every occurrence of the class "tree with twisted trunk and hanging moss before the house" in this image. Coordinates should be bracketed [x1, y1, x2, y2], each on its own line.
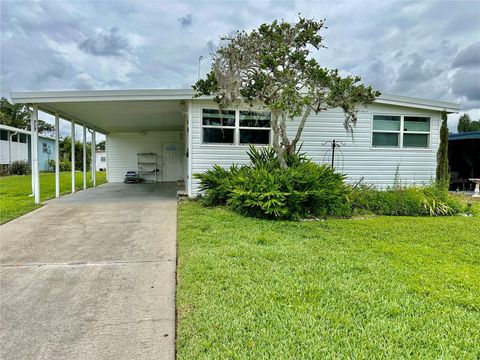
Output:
[193, 17, 380, 169]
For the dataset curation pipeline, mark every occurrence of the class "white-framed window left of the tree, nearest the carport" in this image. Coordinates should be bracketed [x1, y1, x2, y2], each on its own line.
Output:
[202, 109, 271, 145]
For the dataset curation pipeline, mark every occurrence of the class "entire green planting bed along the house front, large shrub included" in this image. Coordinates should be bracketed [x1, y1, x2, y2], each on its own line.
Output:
[194, 147, 466, 219]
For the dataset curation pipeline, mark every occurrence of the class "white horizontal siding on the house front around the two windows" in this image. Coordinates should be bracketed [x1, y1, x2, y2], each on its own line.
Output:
[191, 101, 440, 195]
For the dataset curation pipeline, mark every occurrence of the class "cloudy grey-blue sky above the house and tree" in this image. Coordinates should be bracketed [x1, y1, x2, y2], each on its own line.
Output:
[0, 0, 480, 131]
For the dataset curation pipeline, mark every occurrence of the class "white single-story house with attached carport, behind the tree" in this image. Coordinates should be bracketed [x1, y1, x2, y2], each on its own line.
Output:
[11, 89, 460, 201]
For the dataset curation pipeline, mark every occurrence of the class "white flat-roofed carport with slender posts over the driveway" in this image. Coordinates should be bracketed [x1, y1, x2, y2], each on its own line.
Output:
[11, 89, 193, 203]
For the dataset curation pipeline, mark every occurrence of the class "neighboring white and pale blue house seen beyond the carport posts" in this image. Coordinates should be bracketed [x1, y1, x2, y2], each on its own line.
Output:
[0, 124, 55, 171]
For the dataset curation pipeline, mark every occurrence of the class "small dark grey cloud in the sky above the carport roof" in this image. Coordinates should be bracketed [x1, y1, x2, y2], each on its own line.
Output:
[78, 27, 128, 56]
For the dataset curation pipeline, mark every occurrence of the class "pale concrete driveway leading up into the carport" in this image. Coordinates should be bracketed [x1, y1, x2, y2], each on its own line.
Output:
[0, 184, 177, 360]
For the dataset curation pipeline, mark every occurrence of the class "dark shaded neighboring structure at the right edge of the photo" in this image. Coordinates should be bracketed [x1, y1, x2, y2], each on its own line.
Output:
[448, 131, 480, 190]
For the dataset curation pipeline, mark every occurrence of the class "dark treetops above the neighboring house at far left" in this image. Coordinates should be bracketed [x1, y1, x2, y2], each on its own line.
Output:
[0, 97, 55, 133]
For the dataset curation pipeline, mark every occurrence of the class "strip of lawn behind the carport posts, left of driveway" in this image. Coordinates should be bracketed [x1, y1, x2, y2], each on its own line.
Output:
[0, 171, 106, 224]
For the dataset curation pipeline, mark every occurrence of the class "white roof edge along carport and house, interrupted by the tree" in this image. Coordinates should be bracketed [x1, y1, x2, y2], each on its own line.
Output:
[10, 89, 460, 115]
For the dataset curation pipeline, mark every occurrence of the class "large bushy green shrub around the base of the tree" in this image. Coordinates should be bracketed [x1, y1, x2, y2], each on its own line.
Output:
[195, 147, 351, 219]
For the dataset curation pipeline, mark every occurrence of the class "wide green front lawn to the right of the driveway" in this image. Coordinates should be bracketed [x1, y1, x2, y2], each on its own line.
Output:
[177, 202, 480, 359]
